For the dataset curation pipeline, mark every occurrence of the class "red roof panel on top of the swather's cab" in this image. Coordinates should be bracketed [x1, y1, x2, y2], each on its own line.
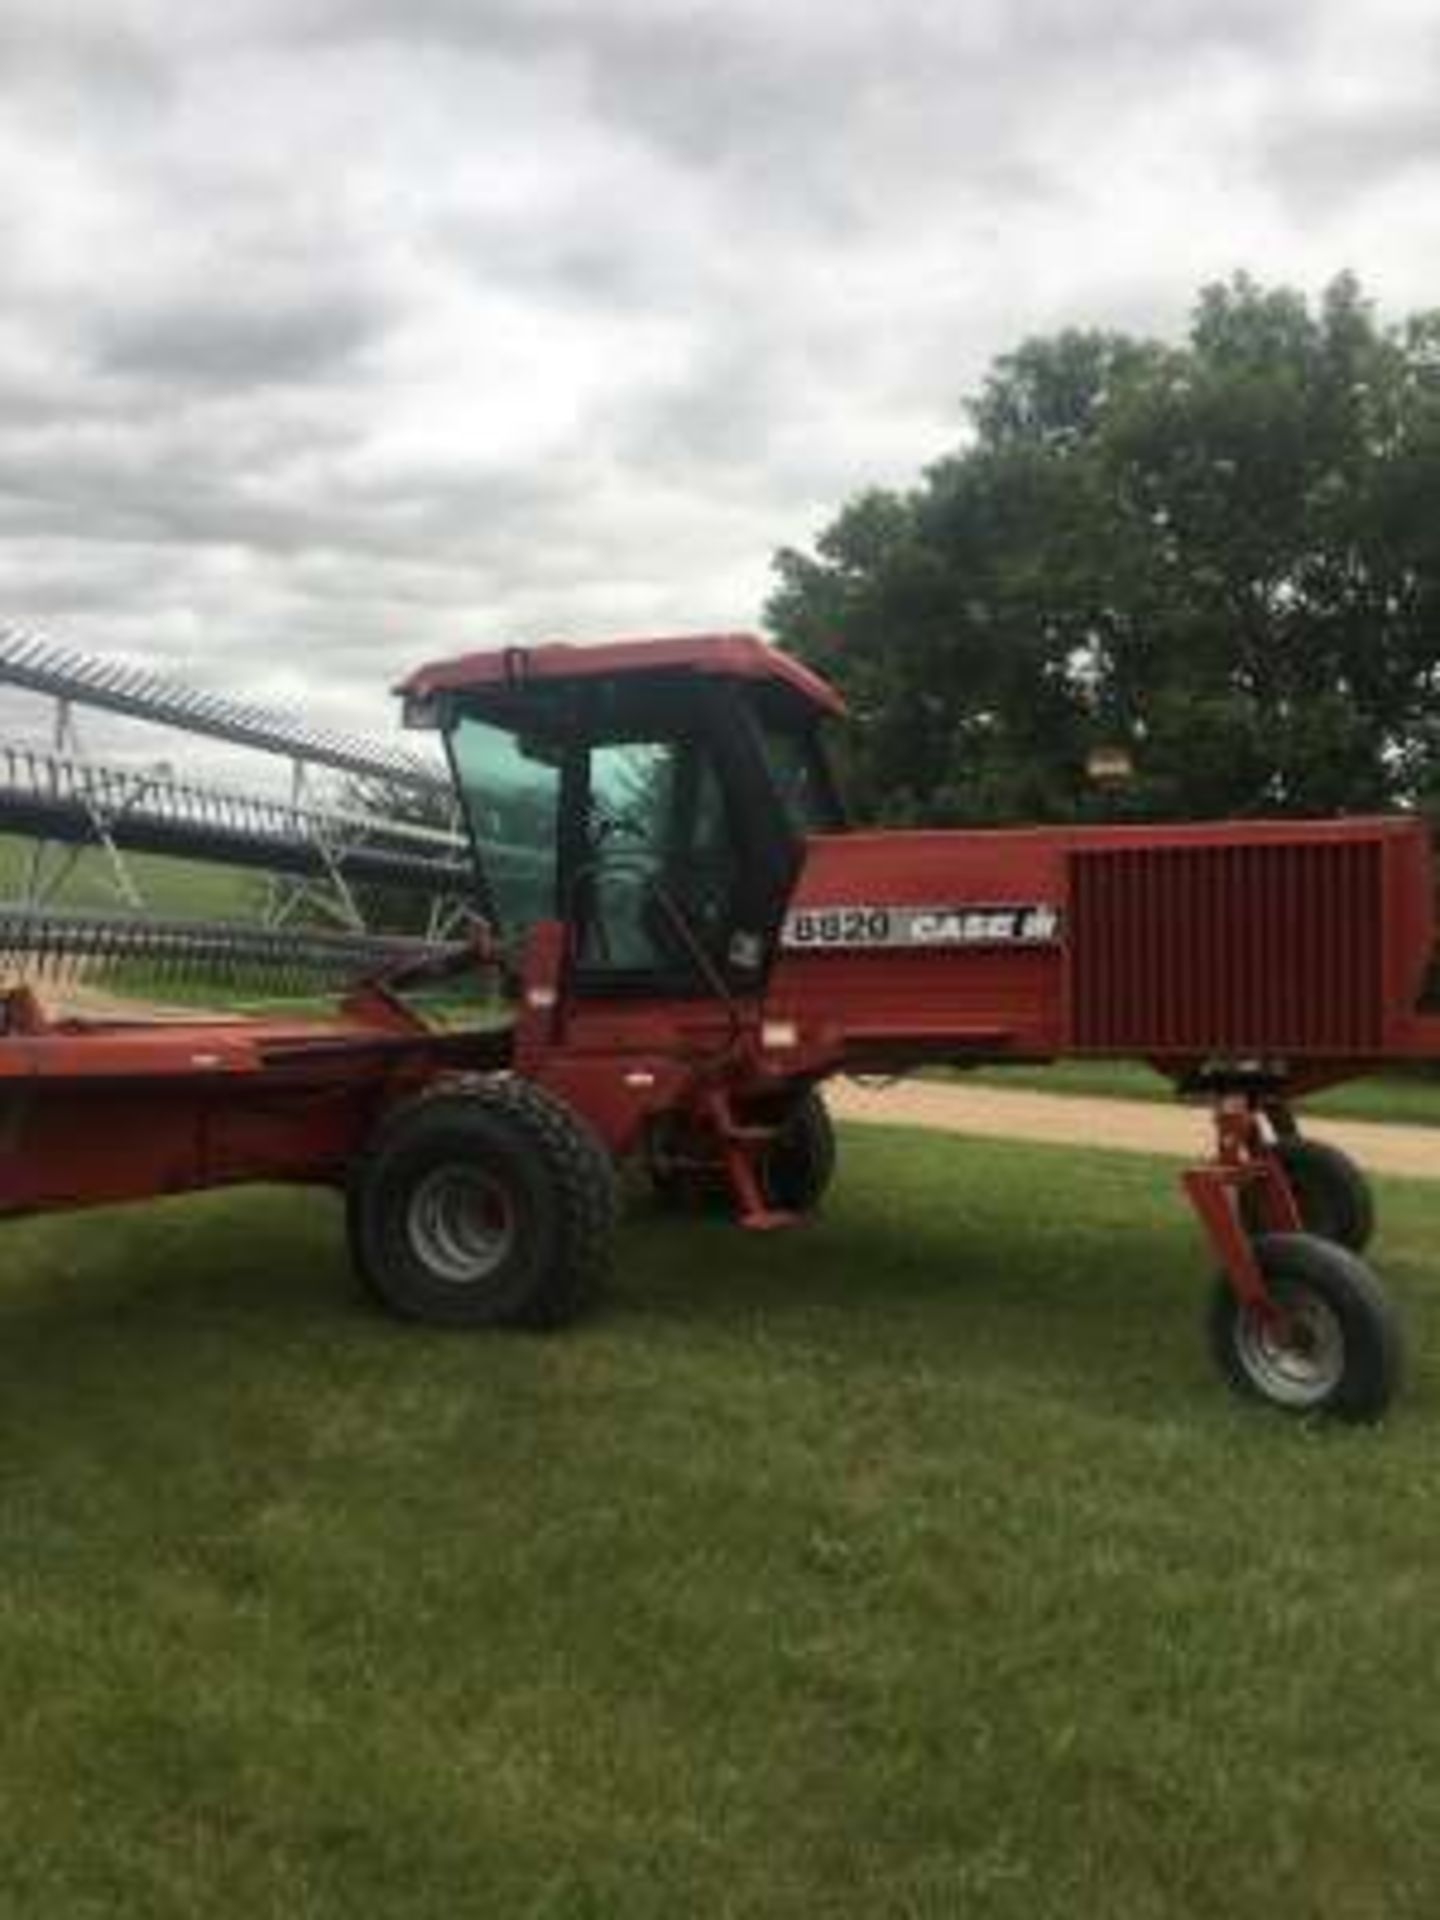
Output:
[396, 634, 845, 714]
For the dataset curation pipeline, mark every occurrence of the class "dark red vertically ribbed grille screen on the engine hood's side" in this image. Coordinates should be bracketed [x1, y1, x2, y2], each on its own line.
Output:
[1069, 841, 1384, 1054]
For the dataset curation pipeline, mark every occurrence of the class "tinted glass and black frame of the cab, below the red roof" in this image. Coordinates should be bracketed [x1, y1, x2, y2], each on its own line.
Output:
[447, 674, 806, 996]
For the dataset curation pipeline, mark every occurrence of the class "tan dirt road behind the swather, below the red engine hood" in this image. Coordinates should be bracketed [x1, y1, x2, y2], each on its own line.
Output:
[826, 1081, 1440, 1181]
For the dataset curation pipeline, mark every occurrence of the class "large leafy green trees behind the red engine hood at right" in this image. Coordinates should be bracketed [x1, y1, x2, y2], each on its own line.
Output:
[768, 275, 1440, 822]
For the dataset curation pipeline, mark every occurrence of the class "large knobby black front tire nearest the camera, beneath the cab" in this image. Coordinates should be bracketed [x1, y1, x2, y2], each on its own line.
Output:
[348, 1079, 618, 1329]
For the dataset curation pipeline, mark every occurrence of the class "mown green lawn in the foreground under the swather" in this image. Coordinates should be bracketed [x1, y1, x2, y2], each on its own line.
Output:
[0, 1129, 1440, 1920]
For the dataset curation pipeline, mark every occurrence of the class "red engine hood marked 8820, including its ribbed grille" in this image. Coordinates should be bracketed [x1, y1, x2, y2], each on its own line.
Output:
[770, 820, 1440, 1066]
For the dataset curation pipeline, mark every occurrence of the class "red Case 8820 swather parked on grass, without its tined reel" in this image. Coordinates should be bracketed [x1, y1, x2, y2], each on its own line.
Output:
[0, 636, 1440, 1417]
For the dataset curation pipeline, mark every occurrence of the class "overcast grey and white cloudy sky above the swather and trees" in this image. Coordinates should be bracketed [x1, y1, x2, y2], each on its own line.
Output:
[0, 0, 1440, 764]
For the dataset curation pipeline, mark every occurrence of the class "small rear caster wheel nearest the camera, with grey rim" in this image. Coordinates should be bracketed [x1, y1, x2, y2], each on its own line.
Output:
[1210, 1233, 1404, 1421]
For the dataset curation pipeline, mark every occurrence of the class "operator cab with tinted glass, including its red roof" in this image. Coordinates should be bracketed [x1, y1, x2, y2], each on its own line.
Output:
[401, 636, 843, 995]
